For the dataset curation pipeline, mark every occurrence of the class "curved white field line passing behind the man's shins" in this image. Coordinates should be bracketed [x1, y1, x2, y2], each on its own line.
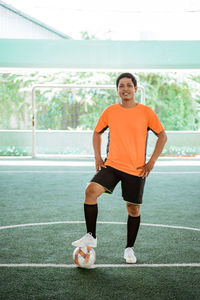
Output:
[0, 221, 200, 231]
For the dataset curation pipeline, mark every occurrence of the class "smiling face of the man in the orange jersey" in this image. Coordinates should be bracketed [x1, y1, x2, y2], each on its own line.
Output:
[117, 77, 137, 101]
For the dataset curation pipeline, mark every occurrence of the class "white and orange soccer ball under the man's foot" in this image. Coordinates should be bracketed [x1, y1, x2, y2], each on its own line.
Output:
[73, 246, 96, 269]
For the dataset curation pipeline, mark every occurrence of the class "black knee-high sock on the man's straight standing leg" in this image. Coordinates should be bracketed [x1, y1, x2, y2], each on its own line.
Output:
[126, 216, 140, 248]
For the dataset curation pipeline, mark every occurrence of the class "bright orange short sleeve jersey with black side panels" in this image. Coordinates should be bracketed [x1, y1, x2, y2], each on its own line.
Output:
[94, 104, 164, 176]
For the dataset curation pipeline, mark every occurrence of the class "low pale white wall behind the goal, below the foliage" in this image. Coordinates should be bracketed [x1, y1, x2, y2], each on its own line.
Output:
[0, 130, 200, 155]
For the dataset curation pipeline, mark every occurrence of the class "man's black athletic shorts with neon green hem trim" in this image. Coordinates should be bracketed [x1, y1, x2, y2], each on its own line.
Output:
[91, 166, 145, 204]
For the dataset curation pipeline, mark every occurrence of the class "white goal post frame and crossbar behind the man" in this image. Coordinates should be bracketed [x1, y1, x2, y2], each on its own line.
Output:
[32, 84, 145, 158]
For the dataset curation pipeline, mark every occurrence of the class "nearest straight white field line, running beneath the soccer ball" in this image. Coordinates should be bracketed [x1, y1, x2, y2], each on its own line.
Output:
[0, 263, 200, 269]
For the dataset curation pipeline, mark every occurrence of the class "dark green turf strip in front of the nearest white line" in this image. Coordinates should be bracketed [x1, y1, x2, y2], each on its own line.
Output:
[1, 267, 200, 300]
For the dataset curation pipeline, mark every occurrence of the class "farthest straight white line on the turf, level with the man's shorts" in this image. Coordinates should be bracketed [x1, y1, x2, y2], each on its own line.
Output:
[0, 170, 200, 175]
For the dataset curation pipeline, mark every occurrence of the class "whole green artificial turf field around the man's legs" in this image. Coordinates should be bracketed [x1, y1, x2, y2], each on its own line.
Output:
[0, 159, 200, 300]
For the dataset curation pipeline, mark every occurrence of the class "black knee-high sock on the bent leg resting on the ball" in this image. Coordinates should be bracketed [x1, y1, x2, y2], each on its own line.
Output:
[84, 204, 98, 238]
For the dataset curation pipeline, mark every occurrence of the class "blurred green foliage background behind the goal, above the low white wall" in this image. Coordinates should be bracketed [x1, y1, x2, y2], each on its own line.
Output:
[0, 71, 200, 131]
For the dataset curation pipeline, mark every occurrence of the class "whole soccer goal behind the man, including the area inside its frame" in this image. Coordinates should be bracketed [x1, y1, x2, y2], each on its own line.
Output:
[32, 84, 145, 158]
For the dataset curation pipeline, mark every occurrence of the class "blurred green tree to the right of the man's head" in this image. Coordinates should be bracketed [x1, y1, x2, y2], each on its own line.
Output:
[138, 73, 199, 130]
